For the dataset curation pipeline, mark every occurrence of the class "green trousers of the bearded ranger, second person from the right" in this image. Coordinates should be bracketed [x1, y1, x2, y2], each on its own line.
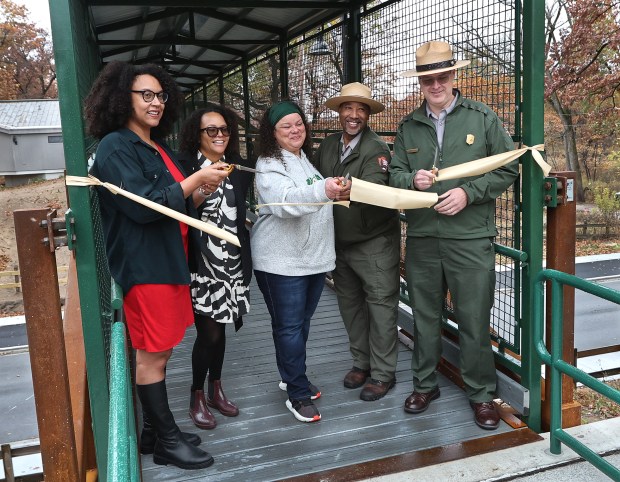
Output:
[333, 232, 400, 382]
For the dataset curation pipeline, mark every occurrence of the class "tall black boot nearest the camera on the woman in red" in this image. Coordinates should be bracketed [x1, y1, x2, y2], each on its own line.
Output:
[136, 380, 213, 469]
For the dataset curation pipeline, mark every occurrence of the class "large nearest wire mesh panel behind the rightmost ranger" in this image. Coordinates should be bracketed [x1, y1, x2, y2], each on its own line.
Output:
[361, 0, 520, 353]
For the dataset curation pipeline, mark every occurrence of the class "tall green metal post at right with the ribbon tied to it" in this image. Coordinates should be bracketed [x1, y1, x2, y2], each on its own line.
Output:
[521, 0, 545, 431]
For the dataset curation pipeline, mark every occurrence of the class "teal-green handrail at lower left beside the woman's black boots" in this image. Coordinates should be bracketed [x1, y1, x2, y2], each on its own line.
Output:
[107, 322, 140, 482]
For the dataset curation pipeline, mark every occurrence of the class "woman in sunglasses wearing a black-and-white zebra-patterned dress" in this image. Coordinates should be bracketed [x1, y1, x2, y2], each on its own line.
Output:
[178, 102, 253, 429]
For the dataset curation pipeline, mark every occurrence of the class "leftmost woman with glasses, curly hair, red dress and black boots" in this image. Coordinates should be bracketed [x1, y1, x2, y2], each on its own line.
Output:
[84, 62, 228, 469]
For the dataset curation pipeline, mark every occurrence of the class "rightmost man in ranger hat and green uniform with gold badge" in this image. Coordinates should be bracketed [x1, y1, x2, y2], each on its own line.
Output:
[390, 41, 518, 430]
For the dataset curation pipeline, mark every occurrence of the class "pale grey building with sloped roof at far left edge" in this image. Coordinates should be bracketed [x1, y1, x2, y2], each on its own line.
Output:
[0, 99, 65, 186]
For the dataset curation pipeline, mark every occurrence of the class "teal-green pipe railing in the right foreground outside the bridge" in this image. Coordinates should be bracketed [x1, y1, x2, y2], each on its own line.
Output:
[533, 269, 620, 480]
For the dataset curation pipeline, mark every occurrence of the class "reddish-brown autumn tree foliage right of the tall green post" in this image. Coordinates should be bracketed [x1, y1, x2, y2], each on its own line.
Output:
[545, 0, 620, 200]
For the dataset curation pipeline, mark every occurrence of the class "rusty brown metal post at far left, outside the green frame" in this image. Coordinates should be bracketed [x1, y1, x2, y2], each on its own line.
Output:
[13, 209, 79, 482]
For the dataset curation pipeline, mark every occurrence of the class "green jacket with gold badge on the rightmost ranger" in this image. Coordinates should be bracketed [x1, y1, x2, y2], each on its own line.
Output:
[390, 91, 518, 239]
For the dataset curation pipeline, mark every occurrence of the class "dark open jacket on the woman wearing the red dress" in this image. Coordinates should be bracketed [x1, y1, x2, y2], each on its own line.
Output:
[91, 129, 199, 293]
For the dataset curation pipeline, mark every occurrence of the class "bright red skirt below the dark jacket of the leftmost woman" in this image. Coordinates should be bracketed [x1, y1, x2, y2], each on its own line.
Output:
[123, 284, 194, 353]
